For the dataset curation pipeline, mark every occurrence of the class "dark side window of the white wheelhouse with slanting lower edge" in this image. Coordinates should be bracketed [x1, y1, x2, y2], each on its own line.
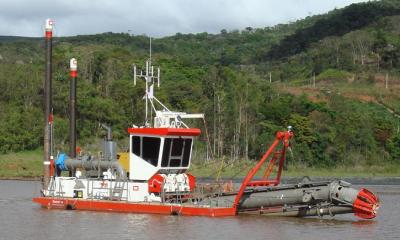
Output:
[131, 136, 161, 167]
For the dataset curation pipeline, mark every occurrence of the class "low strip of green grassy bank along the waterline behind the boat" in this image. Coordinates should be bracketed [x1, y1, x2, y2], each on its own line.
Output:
[0, 150, 400, 179]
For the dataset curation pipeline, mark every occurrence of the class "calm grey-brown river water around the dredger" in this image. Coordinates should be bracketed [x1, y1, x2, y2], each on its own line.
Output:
[0, 180, 400, 240]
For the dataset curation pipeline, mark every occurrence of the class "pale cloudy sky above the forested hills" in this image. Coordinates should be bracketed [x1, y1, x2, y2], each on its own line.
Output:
[0, 0, 365, 37]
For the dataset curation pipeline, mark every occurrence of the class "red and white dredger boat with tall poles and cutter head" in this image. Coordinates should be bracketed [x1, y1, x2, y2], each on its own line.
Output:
[33, 20, 379, 219]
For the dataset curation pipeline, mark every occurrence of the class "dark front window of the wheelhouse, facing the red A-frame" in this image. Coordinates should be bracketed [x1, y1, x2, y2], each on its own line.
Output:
[161, 138, 192, 167]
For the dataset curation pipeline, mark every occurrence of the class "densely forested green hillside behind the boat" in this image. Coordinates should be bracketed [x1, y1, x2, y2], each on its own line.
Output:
[0, 1, 400, 171]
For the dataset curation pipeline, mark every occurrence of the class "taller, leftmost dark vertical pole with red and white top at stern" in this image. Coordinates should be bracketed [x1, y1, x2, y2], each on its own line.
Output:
[43, 19, 53, 189]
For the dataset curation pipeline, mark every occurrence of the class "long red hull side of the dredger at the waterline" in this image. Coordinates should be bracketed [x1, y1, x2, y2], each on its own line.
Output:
[32, 197, 236, 217]
